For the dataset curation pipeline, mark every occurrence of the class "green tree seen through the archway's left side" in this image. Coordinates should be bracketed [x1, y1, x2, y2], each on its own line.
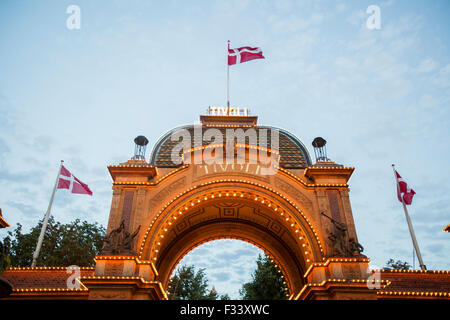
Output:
[168, 265, 218, 300]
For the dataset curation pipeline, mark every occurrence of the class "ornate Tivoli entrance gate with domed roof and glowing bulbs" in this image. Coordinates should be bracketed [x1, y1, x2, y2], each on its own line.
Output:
[83, 112, 371, 299]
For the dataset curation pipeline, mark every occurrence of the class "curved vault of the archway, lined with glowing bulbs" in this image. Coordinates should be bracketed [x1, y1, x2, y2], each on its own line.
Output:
[140, 183, 322, 293]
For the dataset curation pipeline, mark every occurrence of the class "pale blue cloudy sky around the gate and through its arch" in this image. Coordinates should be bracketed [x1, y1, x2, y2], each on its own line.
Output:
[0, 0, 450, 297]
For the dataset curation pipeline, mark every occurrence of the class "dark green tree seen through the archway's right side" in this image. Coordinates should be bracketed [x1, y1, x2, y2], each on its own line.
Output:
[239, 254, 286, 300]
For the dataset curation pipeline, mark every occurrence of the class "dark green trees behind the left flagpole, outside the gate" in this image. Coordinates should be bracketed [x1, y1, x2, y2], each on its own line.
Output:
[3, 216, 105, 267]
